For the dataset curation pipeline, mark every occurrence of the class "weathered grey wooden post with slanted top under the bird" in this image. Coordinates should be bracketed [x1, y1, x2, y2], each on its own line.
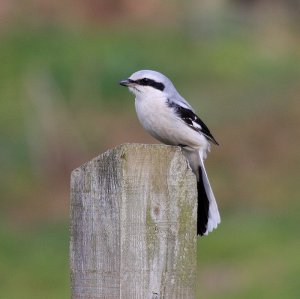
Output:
[70, 144, 197, 299]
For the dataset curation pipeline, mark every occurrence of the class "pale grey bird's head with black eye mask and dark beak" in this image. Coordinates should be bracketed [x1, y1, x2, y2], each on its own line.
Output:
[120, 70, 176, 96]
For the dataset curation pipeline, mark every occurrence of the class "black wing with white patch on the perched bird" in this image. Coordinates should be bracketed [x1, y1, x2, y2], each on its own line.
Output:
[168, 100, 219, 145]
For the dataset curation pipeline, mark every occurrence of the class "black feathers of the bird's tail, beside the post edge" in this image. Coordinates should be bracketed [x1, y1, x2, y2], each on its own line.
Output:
[197, 166, 209, 236]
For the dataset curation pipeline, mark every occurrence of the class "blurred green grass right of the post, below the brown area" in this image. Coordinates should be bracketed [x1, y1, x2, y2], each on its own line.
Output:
[198, 212, 300, 298]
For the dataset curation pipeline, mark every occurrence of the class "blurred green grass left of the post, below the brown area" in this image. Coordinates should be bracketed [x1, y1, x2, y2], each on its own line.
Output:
[0, 223, 70, 299]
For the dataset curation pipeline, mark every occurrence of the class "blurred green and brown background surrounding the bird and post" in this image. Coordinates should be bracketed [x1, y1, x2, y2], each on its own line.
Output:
[0, 0, 300, 299]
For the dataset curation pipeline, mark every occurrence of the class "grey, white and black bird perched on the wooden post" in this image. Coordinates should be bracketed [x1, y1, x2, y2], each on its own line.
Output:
[119, 70, 221, 236]
